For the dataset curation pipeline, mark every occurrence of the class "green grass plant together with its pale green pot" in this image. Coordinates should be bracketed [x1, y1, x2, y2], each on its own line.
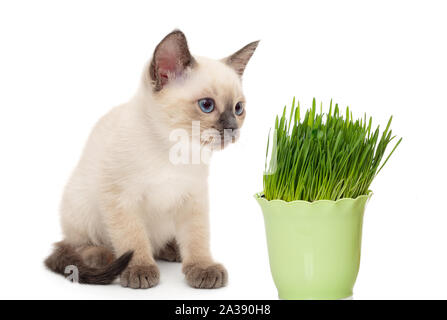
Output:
[255, 99, 402, 299]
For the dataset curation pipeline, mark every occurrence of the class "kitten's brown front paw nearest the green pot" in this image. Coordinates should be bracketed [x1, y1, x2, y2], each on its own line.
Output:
[183, 264, 228, 289]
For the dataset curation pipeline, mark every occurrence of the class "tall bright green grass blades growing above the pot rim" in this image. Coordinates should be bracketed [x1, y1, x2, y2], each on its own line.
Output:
[264, 98, 402, 202]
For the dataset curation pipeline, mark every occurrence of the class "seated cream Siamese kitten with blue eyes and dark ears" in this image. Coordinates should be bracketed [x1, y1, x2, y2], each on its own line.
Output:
[45, 30, 258, 288]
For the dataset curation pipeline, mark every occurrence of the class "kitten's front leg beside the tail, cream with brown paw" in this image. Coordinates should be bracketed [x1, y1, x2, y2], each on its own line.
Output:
[104, 201, 160, 289]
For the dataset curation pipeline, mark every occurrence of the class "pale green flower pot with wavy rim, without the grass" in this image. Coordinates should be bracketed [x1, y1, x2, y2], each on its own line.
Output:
[255, 194, 371, 300]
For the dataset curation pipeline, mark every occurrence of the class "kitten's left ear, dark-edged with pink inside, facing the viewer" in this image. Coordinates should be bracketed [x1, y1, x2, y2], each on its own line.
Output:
[149, 30, 194, 91]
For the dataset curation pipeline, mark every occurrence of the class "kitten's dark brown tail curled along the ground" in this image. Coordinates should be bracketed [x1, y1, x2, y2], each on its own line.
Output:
[45, 242, 133, 284]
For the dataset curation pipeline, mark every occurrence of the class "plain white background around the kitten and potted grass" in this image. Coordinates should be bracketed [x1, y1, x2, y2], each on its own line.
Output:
[0, 0, 447, 299]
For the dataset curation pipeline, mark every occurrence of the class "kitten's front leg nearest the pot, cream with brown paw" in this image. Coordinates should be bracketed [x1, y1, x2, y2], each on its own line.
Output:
[176, 195, 228, 289]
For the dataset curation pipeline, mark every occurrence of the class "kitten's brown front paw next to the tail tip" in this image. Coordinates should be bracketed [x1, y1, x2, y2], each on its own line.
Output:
[120, 264, 160, 289]
